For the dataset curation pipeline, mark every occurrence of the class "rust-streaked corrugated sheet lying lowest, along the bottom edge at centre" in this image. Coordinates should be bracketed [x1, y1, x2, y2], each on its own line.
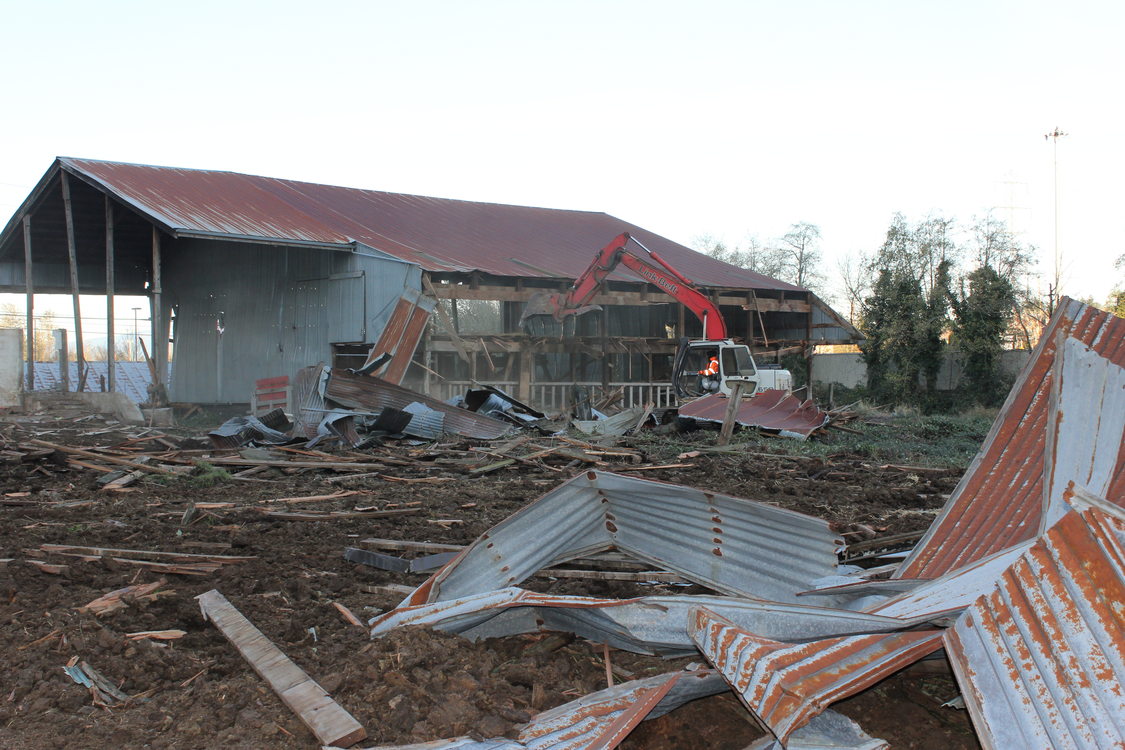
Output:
[353, 669, 727, 750]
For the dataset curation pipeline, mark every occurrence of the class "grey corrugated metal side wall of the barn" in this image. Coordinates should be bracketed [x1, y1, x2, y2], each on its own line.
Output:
[163, 240, 421, 404]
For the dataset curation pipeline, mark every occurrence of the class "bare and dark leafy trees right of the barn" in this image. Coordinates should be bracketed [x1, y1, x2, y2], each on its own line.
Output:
[696, 214, 1125, 412]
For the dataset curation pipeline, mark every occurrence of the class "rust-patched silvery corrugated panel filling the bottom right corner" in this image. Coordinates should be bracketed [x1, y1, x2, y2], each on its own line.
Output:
[945, 493, 1125, 750]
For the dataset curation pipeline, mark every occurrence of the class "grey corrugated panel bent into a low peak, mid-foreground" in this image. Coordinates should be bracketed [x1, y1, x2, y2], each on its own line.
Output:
[400, 472, 839, 606]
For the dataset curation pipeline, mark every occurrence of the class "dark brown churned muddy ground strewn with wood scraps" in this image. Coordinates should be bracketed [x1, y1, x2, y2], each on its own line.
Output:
[0, 415, 979, 750]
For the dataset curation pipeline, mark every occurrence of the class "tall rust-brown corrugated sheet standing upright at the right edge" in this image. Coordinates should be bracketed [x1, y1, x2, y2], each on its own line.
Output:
[894, 298, 1125, 578]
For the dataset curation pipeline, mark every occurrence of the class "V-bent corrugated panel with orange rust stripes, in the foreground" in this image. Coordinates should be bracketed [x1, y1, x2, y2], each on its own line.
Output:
[691, 607, 943, 744]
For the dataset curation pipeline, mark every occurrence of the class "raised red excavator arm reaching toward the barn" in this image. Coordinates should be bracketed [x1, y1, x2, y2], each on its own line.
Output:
[523, 233, 727, 341]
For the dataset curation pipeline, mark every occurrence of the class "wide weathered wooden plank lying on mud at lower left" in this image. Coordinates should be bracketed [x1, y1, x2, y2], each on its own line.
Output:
[196, 589, 367, 748]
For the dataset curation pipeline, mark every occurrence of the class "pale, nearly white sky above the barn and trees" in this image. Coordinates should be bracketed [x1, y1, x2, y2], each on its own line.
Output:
[0, 0, 1125, 317]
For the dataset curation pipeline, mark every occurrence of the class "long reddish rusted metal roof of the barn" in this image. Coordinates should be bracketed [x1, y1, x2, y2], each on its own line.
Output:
[52, 156, 800, 291]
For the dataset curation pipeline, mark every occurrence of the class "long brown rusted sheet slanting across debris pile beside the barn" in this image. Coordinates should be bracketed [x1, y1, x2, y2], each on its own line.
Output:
[324, 369, 512, 440]
